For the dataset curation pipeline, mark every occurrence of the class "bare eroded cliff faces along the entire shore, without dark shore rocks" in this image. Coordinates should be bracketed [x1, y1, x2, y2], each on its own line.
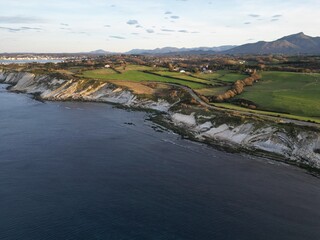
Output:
[0, 70, 320, 169]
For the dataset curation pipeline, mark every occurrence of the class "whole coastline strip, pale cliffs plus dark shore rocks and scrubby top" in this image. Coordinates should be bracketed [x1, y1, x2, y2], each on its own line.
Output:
[0, 70, 320, 174]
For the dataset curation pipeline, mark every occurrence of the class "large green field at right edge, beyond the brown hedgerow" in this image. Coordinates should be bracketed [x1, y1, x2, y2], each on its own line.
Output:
[237, 72, 320, 119]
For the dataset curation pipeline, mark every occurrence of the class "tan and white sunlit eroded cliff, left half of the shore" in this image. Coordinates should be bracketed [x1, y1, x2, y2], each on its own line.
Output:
[0, 70, 171, 112]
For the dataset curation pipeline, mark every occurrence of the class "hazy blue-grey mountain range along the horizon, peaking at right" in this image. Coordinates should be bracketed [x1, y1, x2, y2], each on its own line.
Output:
[89, 32, 320, 55]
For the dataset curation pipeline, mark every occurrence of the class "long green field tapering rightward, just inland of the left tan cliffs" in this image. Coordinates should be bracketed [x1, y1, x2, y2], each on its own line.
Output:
[80, 67, 206, 89]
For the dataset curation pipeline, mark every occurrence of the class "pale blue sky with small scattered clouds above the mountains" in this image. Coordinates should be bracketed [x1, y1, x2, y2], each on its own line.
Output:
[0, 0, 320, 53]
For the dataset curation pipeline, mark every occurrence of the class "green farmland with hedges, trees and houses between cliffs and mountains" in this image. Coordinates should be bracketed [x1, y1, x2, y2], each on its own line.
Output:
[2, 55, 320, 122]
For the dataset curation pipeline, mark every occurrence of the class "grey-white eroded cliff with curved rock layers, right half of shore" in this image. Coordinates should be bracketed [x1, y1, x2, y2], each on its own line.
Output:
[171, 113, 320, 169]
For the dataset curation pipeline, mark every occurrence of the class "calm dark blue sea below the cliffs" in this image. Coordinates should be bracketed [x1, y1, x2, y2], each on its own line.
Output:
[0, 85, 320, 240]
